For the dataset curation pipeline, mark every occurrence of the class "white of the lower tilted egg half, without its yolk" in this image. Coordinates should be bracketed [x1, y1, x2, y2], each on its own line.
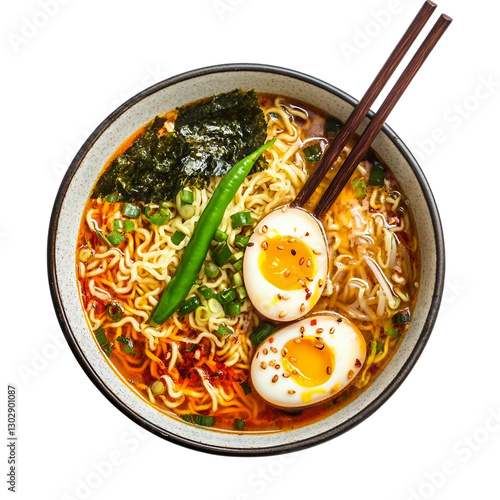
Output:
[250, 313, 366, 408]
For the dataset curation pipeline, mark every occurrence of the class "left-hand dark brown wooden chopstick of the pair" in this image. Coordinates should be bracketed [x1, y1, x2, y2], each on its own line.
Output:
[294, 0, 437, 207]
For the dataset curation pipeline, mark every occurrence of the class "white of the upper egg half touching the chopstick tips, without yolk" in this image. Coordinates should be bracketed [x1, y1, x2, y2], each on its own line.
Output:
[243, 208, 328, 322]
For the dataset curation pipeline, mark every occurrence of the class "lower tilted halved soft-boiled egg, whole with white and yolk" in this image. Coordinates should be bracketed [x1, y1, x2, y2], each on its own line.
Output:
[250, 313, 366, 408]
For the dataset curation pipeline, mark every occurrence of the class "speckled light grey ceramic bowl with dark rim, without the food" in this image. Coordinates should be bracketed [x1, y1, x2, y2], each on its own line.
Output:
[48, 64, 444, 456]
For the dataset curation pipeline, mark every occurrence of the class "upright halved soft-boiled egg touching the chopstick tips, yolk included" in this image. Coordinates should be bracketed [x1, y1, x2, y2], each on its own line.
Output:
[243, 208, 328, 321]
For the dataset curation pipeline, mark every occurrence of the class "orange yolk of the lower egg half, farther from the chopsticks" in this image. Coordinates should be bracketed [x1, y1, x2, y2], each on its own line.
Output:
[282, 337, 335, 387]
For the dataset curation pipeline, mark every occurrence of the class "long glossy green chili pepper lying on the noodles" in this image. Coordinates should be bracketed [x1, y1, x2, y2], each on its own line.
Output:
[148, 139, 276, 326]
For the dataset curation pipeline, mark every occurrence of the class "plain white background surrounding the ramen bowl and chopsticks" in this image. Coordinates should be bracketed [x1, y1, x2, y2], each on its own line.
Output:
[0, 0, 500, 500]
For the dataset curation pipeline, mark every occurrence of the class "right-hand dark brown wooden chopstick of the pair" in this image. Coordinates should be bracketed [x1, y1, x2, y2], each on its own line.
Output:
[314, 14, 452, 219]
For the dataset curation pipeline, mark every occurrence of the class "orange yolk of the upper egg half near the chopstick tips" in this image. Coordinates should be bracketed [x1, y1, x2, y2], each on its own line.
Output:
[259, 236, 317, 291]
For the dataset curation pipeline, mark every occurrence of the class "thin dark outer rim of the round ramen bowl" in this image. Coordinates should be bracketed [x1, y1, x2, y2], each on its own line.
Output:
[47, 63, 445, 456]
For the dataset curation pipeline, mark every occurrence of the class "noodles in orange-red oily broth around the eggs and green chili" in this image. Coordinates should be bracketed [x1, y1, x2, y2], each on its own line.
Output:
[76, 94, 419, 432]
